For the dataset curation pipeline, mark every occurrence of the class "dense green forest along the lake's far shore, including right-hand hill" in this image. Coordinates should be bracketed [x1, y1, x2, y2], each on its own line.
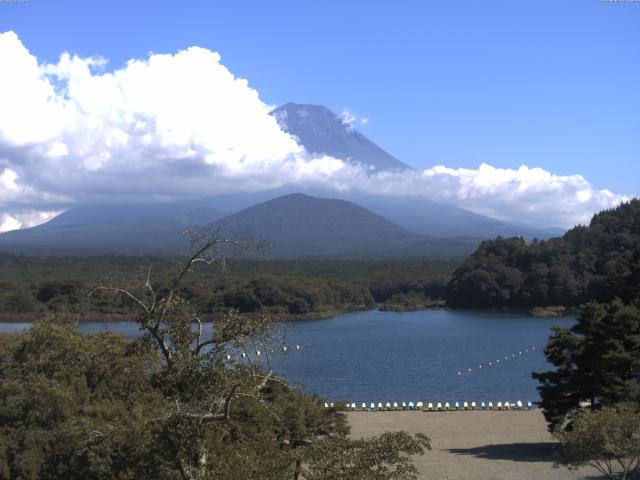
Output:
[5, 200, 640, 321]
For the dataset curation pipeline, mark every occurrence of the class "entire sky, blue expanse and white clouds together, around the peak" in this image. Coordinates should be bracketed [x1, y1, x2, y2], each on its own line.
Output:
[0, 0, 640, 232]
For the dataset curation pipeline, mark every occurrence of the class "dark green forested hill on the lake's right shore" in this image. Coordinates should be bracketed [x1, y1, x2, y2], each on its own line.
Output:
[447, 199, 640, 307]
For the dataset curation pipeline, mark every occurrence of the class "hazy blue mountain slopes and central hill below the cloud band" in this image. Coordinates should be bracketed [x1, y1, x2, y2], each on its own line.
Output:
[0, 192, 560, 259]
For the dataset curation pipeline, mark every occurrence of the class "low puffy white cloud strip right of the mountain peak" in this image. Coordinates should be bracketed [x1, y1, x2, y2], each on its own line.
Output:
[360, 164, 630, 228]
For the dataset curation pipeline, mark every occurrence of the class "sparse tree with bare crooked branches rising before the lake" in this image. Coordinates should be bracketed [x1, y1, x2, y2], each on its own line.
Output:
[90, 235, 286, 480]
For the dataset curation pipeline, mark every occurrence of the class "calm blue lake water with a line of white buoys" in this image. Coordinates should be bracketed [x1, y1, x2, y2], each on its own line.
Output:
[0, 310, 575, 404]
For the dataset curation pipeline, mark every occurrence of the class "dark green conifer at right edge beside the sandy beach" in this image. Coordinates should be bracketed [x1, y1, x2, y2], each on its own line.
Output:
[533, 299, 640, 430]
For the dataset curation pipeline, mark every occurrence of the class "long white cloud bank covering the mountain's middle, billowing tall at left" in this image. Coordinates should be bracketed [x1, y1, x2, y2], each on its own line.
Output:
[0, 32, 626, 231]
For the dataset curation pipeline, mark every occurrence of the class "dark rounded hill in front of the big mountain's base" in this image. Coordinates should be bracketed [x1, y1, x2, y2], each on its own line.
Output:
[208, 193, 480, 259]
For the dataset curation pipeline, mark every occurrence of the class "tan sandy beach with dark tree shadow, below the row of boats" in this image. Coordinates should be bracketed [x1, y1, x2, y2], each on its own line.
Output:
[348, 410, 600, 480]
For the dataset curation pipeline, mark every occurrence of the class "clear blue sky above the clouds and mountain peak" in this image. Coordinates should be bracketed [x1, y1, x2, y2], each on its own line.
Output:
[0, 0, 640, 195]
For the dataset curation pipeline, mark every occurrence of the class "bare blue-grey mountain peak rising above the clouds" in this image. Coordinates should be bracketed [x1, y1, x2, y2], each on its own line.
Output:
[271, 103, 410, 171]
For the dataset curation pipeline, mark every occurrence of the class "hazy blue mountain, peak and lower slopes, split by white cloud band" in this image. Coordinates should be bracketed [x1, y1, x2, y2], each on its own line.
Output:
[0, 99, 562, 253]
